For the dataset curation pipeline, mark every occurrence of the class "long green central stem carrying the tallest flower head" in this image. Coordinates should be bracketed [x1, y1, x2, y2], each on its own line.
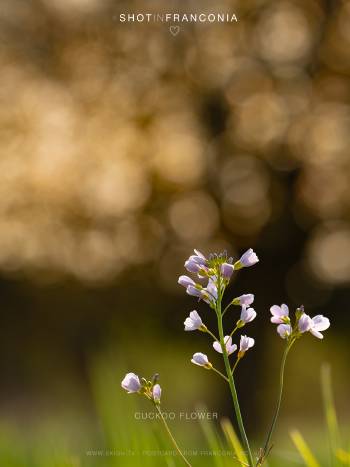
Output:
[216, 275, 255, 467]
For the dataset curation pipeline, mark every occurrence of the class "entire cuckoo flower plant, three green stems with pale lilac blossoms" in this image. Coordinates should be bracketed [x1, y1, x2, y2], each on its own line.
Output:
[122, 248, 330, 467]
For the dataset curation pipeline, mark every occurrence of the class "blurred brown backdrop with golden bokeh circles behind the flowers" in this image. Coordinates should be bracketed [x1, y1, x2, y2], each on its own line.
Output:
[0, 0, 350, 466]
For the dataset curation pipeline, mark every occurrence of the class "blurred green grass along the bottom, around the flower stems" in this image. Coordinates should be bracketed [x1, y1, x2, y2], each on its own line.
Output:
[0, 357, 350, 467]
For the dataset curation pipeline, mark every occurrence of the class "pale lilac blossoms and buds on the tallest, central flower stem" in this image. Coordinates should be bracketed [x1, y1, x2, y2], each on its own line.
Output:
[178, 249, 259, 371]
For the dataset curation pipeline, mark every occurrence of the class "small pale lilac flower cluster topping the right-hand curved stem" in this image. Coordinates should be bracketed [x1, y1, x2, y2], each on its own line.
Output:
[270, 303, 330, 341]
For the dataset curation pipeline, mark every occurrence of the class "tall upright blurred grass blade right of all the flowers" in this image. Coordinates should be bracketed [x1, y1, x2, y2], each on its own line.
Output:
[321, 364, 340, 465]
